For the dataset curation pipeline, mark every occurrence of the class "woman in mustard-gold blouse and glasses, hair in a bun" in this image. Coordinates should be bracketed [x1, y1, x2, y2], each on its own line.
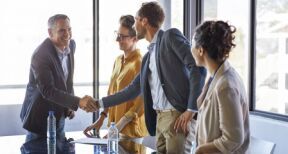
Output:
[84, 15, 148, 138]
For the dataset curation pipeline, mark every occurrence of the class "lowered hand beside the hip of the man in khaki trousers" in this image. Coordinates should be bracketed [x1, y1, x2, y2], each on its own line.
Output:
[174, 111, 194, 134]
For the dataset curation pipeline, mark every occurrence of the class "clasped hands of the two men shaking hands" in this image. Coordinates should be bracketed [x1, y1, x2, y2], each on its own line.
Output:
[79, 95, 100, 112]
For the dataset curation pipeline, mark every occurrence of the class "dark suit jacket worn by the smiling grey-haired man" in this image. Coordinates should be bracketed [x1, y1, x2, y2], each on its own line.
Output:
[20, 38, 80, 136]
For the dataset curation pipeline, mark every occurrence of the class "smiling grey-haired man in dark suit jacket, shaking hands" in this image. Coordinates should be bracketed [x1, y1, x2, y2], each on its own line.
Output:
[20, 14, 97, 142]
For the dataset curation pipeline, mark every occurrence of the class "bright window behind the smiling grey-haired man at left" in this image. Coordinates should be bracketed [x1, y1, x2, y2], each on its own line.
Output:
[0, 0, 93, 135]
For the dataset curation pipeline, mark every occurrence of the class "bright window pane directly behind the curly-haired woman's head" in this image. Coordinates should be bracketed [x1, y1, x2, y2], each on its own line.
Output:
[203, 0, 249, 91]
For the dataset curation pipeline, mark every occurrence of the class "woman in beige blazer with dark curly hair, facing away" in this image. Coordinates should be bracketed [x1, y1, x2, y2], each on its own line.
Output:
[192, 21, 250, 154]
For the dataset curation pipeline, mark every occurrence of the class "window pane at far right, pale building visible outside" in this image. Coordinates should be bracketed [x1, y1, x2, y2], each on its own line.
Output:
[255, 0, 288, 115]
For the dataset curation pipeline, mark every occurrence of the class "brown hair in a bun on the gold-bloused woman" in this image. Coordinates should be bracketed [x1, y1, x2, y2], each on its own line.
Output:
[119, 15, 136, 37]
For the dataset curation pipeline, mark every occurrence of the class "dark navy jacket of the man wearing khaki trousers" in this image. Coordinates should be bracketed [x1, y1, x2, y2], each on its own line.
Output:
[102, 29, 206, 135]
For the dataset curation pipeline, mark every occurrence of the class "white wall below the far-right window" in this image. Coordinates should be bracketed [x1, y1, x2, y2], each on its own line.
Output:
[250, 115, 288, 154]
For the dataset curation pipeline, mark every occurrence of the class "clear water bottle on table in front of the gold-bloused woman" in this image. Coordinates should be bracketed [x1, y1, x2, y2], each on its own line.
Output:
[108, 122, 119, 154]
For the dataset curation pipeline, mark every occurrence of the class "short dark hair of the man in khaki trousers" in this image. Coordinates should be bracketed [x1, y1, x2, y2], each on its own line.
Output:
[137, 2, 165, 28]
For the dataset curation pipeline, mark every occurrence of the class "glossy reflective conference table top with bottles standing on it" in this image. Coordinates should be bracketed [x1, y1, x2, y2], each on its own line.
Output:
[0, 132, 156, 154]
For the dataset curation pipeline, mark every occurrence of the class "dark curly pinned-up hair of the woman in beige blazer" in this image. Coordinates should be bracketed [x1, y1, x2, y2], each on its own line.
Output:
[194, 20, 236, 62]
